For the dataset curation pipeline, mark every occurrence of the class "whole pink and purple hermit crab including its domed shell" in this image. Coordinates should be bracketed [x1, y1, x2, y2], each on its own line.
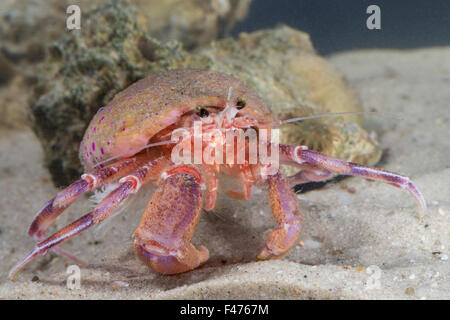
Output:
[10, 69, 426, 278]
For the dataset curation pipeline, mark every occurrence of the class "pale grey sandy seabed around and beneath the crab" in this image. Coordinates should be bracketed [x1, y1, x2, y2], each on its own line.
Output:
[0, 47, 450, 299]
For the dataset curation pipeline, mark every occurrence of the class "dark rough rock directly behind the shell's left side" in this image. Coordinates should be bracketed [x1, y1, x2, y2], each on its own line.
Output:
[31, 2, 188, 185]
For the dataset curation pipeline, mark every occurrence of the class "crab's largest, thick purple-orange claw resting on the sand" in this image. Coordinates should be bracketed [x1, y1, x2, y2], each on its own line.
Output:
[133, 166, 209, 274]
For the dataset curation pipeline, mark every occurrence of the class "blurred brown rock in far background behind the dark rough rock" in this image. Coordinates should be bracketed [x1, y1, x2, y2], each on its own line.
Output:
[0, 0, 251, 127]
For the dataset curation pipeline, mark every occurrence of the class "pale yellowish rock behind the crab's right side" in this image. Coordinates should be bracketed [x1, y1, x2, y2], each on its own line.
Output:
[190, 26, 381, 173]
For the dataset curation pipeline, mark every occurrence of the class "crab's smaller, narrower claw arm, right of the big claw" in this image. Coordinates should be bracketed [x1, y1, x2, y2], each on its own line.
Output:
[256, 172, 302, 260]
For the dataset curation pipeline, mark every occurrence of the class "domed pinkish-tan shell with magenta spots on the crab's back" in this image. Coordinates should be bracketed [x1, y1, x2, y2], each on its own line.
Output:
[79, 69, 273, 170]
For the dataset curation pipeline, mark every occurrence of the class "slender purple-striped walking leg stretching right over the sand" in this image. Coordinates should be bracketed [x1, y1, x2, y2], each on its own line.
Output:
[280, 145, 427, 218]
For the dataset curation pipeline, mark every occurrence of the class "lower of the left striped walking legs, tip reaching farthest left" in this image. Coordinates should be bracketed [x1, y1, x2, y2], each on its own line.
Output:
[9, 158, 166, 279]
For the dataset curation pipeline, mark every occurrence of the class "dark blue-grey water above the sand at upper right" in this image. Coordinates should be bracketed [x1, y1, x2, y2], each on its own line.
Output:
[233, 0, 450, 54]
